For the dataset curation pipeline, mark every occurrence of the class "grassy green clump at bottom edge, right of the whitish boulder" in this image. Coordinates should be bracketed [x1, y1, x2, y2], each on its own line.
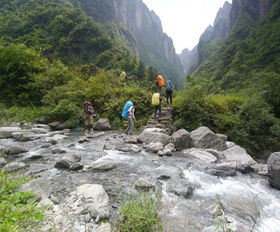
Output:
[118, 195, 162, 232]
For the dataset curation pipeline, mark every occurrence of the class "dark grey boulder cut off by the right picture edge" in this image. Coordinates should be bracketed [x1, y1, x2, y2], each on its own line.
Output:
[267, 152, 280, 189]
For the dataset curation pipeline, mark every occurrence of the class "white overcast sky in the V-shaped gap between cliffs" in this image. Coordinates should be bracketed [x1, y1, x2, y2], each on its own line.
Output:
[143, 0, 231, 53]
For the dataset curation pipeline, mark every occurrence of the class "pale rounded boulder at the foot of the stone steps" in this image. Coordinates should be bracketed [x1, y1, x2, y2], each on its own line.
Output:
[138, 128, 170, 146]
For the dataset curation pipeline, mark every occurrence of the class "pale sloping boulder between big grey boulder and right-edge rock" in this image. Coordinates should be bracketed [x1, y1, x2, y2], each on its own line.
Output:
[222, 145, 257, 173]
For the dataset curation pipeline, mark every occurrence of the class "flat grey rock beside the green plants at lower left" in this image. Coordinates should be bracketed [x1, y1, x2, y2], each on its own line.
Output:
[19, 178, 51, 199]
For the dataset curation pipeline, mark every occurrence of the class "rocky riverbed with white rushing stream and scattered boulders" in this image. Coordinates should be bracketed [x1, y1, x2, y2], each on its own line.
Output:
[0, 123, 280, 232]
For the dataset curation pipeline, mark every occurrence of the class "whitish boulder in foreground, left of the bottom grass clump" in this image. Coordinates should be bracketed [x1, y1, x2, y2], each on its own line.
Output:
[76, 184, 109, 219]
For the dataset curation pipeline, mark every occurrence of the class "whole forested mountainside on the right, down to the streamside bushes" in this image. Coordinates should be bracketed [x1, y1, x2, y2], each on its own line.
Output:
[175, 0, 280, 158]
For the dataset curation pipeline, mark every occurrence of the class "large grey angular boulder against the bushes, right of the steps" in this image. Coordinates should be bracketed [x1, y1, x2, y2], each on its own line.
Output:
[190, 126, 227, 151]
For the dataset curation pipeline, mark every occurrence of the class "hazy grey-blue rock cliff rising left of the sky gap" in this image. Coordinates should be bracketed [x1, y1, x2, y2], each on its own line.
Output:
[73, 0, 183, 86]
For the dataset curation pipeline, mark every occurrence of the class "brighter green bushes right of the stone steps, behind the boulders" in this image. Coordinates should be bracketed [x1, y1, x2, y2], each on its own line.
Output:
[174, 78, 280, 158]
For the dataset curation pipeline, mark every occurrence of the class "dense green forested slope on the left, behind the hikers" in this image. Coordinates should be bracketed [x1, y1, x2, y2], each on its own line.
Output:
[0, 0, 156, 127]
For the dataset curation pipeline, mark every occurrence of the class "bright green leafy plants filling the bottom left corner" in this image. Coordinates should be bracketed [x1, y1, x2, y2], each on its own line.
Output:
[0, 171, 43, 232]
